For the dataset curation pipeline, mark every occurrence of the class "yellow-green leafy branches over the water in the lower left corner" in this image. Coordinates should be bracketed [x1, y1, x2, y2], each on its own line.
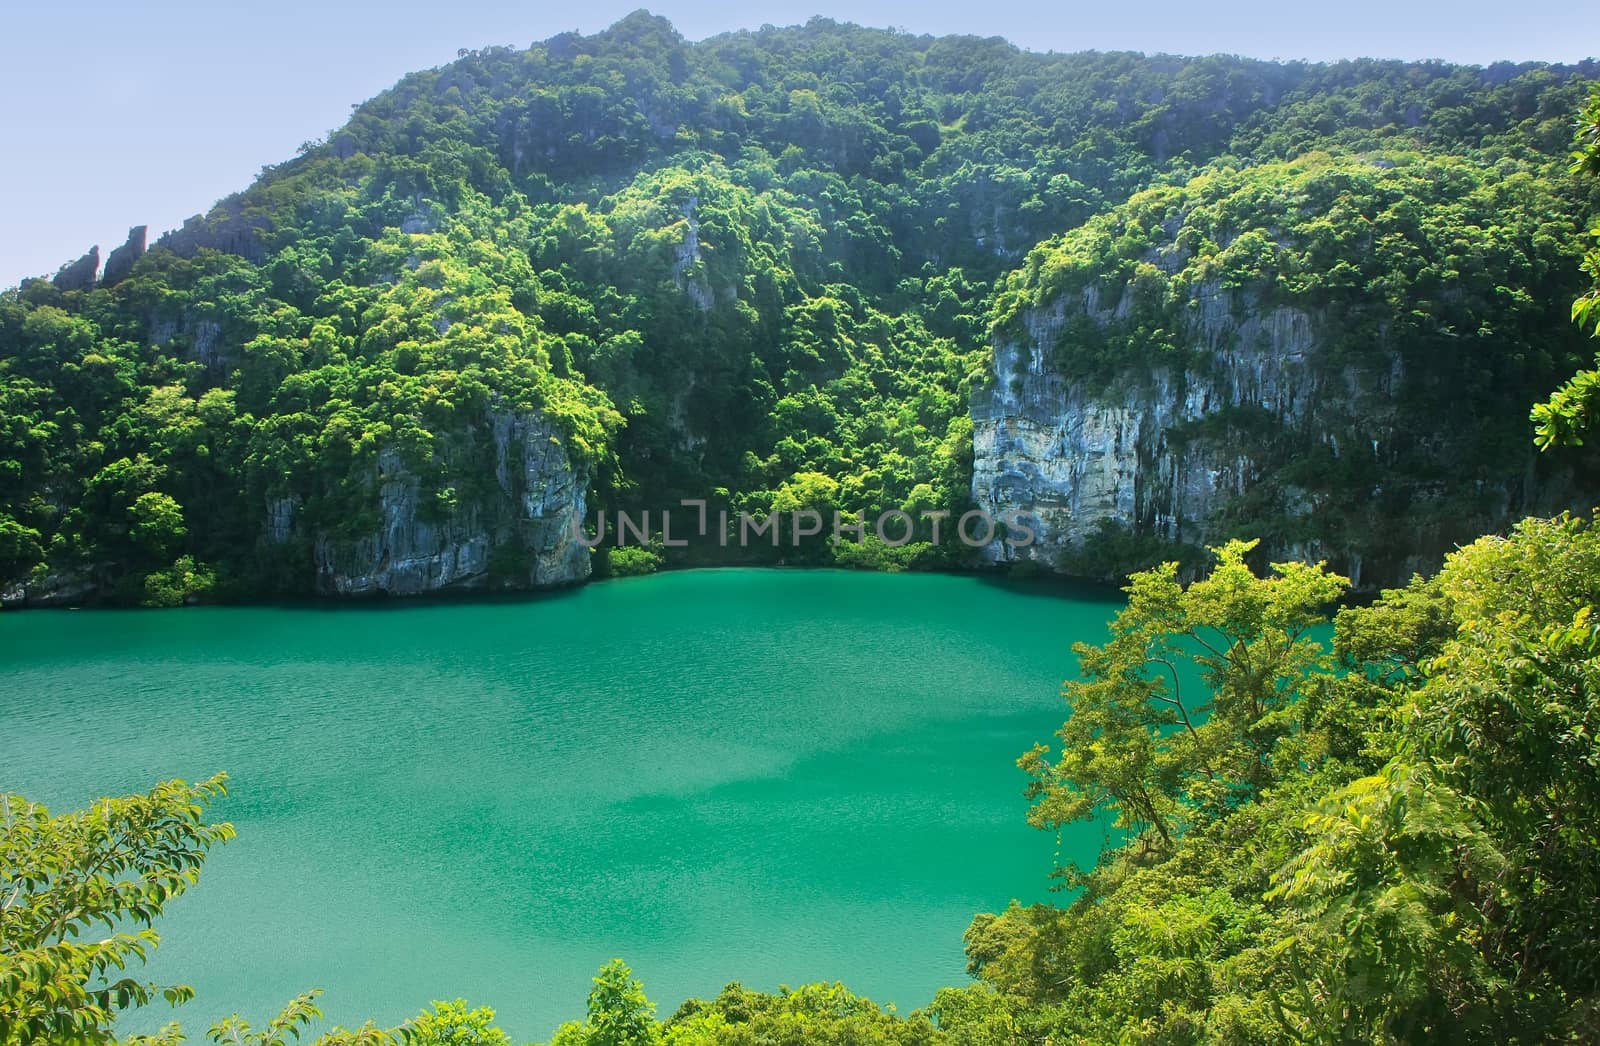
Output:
[0, 774, 234, 1046]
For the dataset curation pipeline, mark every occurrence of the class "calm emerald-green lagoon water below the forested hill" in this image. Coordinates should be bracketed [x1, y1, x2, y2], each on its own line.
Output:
[0, 569, 1117, 1040]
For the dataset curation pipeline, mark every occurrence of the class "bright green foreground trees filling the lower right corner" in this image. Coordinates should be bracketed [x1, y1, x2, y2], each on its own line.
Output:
[966, 518, 1600, 1043]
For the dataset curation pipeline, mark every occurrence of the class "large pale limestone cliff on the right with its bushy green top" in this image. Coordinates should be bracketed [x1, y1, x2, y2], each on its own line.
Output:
[971, 154, 1594, 589]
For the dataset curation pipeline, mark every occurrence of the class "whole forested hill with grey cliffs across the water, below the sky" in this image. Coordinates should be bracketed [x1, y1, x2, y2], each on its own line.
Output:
[0, 13, 1597, 605]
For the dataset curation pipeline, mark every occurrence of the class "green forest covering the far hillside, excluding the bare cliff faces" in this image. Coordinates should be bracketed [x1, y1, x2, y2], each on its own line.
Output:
[0, 13, 1595, 603]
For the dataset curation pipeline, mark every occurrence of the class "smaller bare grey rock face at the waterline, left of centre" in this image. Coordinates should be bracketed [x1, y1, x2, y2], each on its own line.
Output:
[264, 413, 589, 597]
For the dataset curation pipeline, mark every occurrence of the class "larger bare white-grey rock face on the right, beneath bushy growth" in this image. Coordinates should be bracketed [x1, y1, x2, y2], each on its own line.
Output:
[971, 283, 1563, 589]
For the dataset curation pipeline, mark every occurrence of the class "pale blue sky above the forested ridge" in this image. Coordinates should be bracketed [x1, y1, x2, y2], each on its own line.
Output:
[0, 0, 1600, 286]
